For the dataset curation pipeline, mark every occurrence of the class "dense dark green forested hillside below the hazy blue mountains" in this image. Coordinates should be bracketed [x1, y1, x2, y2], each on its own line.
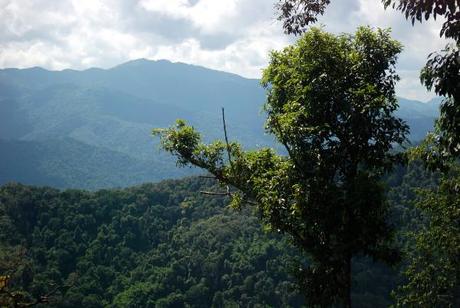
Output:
[0, 164, 436, 307]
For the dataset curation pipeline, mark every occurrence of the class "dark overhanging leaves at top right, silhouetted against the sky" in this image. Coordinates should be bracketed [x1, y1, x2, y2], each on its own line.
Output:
[276, 0, 460, 168]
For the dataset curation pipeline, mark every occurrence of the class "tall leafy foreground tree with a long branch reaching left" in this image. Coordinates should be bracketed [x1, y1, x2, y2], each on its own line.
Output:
[154, 28, 408, 307]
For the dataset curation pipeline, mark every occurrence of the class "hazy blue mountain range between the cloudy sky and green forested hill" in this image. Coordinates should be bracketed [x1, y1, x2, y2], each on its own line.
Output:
[0, 59, 439, 189]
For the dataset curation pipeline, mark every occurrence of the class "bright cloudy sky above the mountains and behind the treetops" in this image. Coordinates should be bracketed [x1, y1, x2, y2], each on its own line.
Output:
[0, 0, 446, 101]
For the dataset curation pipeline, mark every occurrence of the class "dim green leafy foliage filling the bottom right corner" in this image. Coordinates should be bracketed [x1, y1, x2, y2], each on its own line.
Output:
[397, 166, 460, 307]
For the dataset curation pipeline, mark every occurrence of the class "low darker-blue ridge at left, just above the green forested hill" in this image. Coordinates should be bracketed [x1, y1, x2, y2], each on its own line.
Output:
[0, 138, 197, 190]
